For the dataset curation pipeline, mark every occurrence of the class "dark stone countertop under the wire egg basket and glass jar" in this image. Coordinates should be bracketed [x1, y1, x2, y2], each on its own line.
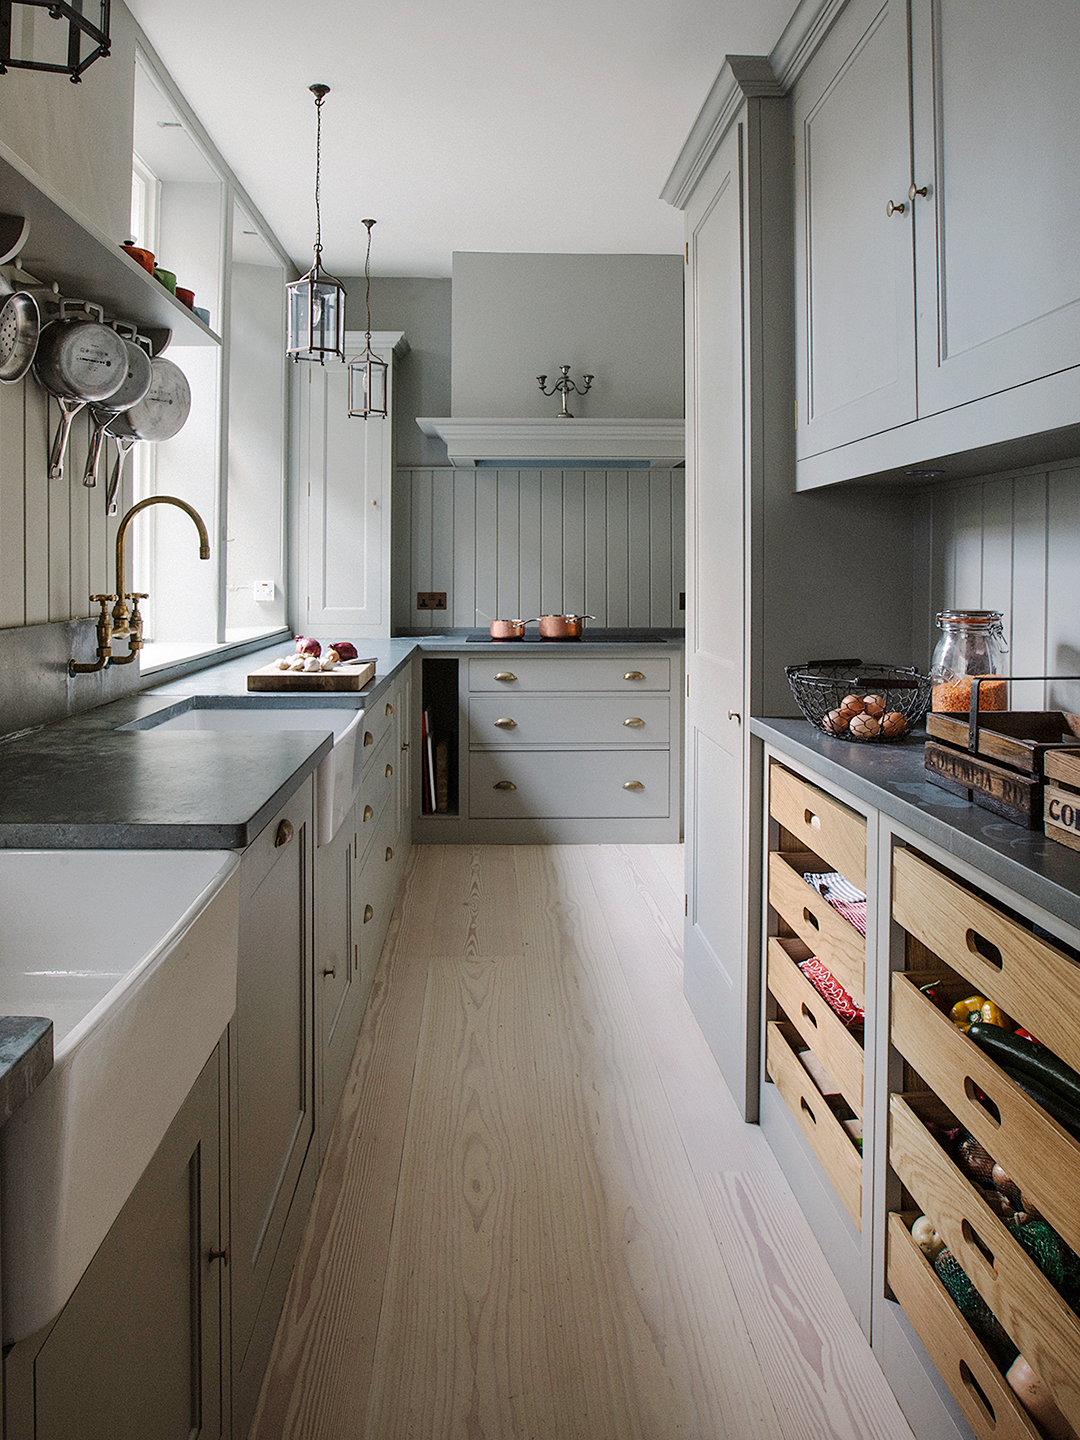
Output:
[750, 719, 1080, 929]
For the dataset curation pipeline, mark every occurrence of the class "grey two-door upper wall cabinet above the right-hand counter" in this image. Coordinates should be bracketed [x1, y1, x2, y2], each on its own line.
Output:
[793, 0, 1080, 490]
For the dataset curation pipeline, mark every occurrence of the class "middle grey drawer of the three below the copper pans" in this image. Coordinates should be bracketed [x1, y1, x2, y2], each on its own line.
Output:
[469, 696, 670, 746]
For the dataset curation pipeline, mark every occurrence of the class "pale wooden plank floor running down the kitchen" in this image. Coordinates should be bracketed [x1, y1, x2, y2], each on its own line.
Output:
[251, 845, 912, 1440]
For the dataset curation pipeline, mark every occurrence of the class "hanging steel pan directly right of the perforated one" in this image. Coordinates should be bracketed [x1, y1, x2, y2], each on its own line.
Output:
[33, 300, 128, 480]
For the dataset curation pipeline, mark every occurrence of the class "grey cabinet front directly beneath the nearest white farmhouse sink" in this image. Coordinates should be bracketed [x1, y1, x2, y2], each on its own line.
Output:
[4, 1045, 229, 1440]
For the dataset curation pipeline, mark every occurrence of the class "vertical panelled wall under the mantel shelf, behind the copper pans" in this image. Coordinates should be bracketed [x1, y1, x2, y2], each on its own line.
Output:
[393, 467, 685, 629]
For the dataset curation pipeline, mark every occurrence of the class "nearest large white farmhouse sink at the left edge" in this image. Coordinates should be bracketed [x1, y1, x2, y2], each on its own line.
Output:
[0, 850, 239, 1344]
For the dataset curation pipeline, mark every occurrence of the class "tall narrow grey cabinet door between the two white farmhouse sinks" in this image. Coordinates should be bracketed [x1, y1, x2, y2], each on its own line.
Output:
[229, 780, 317, 1440]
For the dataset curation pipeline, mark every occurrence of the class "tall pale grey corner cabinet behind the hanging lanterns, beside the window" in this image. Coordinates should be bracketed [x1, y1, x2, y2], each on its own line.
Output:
[297, 331, 408, 639]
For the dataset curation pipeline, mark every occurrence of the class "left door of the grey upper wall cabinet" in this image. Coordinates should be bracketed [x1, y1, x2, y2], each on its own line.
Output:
[793, 0, 916, 458]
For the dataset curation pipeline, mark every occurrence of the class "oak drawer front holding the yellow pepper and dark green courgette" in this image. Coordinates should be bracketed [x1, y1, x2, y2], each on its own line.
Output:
[893, 973, 1080, 1261]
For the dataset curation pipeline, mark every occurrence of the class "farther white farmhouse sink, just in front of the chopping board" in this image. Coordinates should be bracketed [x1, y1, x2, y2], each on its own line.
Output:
[121, 701, 364, 845]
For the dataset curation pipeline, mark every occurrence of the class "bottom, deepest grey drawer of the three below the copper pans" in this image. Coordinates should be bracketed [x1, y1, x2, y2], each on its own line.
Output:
[469, 750, 670, 819]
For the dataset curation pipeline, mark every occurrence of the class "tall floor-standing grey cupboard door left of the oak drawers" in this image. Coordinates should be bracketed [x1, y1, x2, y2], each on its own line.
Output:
[684, 124, 747, 1107]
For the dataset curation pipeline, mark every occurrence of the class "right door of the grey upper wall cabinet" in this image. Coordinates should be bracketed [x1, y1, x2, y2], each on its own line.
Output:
[912, 0, 1080, 426]
